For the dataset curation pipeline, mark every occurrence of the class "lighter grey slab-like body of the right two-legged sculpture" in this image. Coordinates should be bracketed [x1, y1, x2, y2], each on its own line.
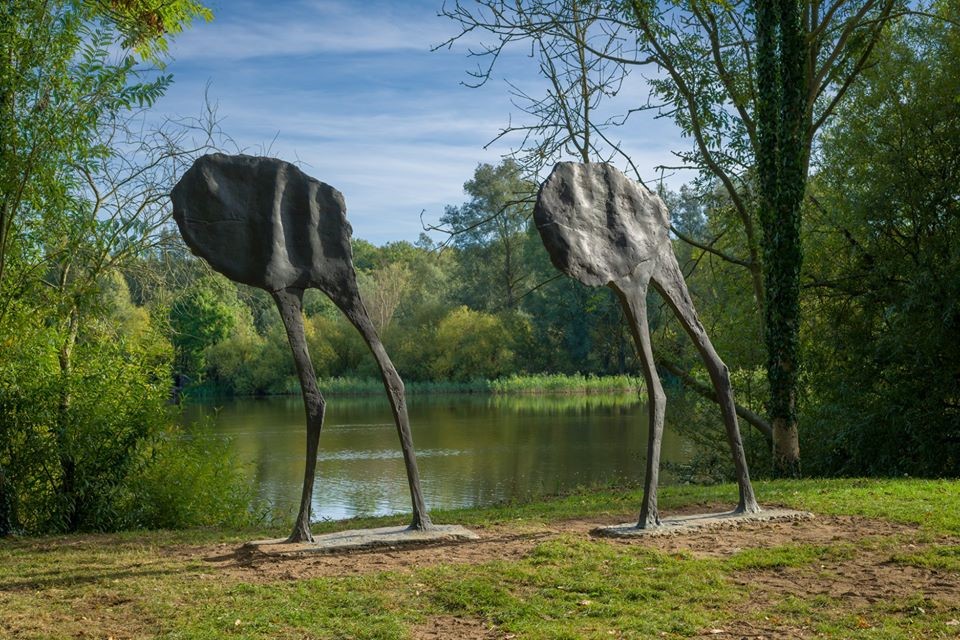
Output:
[533, 162, 670, 286]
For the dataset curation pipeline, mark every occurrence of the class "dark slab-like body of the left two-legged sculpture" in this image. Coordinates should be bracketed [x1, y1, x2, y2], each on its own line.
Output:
[170, 153, 356, 296]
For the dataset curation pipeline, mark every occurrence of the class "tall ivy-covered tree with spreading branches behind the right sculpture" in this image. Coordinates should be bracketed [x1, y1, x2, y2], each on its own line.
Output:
[444, 0, 908, 471]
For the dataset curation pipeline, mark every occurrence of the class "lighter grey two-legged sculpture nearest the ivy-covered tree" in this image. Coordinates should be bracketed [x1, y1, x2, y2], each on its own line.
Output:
[533, 162, 760, 528]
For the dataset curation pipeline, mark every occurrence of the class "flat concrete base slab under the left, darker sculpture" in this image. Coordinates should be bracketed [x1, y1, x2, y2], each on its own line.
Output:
[243, 524, 480, 555]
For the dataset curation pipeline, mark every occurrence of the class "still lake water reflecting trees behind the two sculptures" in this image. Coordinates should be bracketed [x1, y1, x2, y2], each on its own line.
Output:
[184, 394, 692, 520]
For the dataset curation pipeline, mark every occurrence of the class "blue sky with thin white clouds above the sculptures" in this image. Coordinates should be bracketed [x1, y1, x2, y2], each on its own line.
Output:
[156, 0, 686, 244]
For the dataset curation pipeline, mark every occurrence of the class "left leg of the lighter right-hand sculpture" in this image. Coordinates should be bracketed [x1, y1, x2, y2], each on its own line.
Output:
[612, 280, 667, 529]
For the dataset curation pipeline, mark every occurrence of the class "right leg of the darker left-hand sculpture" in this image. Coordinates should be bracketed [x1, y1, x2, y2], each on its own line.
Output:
[334, 295, 433, 530]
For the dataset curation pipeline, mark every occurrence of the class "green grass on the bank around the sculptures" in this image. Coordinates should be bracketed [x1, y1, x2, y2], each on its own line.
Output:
[0, 480, 960, 638]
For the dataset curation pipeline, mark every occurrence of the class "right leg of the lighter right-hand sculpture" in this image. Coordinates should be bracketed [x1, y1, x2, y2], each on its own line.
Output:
[651, 251, 760, 513]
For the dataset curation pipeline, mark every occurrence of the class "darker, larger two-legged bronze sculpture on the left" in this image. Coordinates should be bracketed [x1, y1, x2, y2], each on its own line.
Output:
[170, 154, 431, 542]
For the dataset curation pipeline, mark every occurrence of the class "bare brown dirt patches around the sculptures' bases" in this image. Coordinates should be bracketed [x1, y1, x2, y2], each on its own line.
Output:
[183, 506, 960, 640]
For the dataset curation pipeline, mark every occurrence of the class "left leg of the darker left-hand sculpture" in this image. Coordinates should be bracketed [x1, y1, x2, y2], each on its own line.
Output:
[272, 289, 325, 542]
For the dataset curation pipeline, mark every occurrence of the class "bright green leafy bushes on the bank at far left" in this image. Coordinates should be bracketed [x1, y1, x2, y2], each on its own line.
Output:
[0, 300, 262, 534]
